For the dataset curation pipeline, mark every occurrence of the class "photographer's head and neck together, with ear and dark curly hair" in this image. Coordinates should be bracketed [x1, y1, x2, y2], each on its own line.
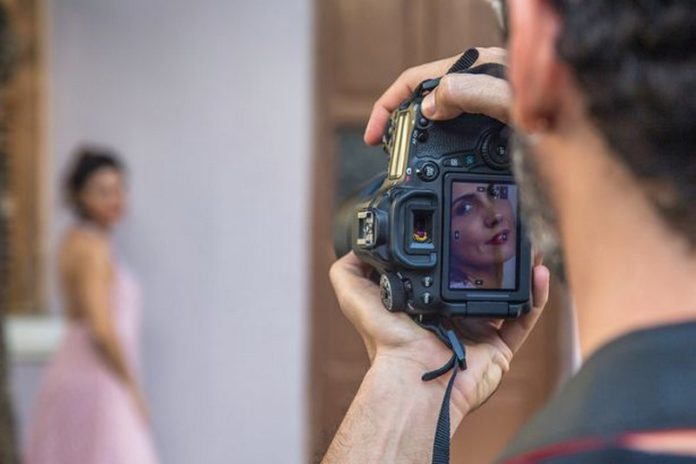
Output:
[508, 0, 696, 348]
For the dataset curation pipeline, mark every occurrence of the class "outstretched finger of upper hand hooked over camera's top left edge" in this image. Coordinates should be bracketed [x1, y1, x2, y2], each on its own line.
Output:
[364, 55, 460, 145]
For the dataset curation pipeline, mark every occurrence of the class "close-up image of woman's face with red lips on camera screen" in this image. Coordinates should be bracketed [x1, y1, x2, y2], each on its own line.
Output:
[449, 181, 518, 290]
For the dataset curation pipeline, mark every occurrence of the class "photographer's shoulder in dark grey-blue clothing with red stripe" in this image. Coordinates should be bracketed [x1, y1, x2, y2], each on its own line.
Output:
[500, 322, 696, 464]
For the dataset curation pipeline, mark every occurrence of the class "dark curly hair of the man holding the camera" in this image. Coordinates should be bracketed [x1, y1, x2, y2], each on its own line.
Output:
[553, 0, 696, 247]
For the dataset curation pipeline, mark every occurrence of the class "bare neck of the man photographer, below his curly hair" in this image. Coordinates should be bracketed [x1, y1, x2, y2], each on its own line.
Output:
[539, 130, 696, 356]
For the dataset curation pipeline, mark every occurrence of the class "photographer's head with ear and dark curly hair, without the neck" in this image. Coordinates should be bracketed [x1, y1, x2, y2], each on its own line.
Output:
[512, 0, 696, 240]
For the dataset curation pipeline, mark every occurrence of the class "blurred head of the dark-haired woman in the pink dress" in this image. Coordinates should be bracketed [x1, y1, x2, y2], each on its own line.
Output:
[65, 147, 126, 229]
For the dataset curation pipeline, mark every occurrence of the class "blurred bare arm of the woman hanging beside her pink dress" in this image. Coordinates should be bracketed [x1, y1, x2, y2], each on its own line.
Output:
[73, 236, 147, 417]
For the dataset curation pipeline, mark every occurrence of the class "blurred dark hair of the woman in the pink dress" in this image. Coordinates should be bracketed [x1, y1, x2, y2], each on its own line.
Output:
[65, 147, 125, 217]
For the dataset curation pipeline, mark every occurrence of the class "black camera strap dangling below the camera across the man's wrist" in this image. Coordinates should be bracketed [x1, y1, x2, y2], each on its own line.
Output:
[420, 321, 466, 464]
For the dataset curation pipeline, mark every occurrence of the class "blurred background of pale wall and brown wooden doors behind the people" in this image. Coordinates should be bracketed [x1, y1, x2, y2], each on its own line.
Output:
[0, 0, 572, 464]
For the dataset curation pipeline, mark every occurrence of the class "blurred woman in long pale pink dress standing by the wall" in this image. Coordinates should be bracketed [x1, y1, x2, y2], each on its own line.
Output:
[26, 149, 157, 464]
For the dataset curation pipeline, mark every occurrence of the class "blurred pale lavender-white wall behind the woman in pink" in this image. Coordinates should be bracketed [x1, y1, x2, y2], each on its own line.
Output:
[15, 0, 312, 464]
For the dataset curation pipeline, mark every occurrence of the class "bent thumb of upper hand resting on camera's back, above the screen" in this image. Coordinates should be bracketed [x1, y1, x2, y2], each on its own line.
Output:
[422, 74, 511, 123]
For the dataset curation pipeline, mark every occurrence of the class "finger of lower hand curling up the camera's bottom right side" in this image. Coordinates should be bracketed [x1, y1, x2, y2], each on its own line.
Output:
[499, 266, 550, 353]
